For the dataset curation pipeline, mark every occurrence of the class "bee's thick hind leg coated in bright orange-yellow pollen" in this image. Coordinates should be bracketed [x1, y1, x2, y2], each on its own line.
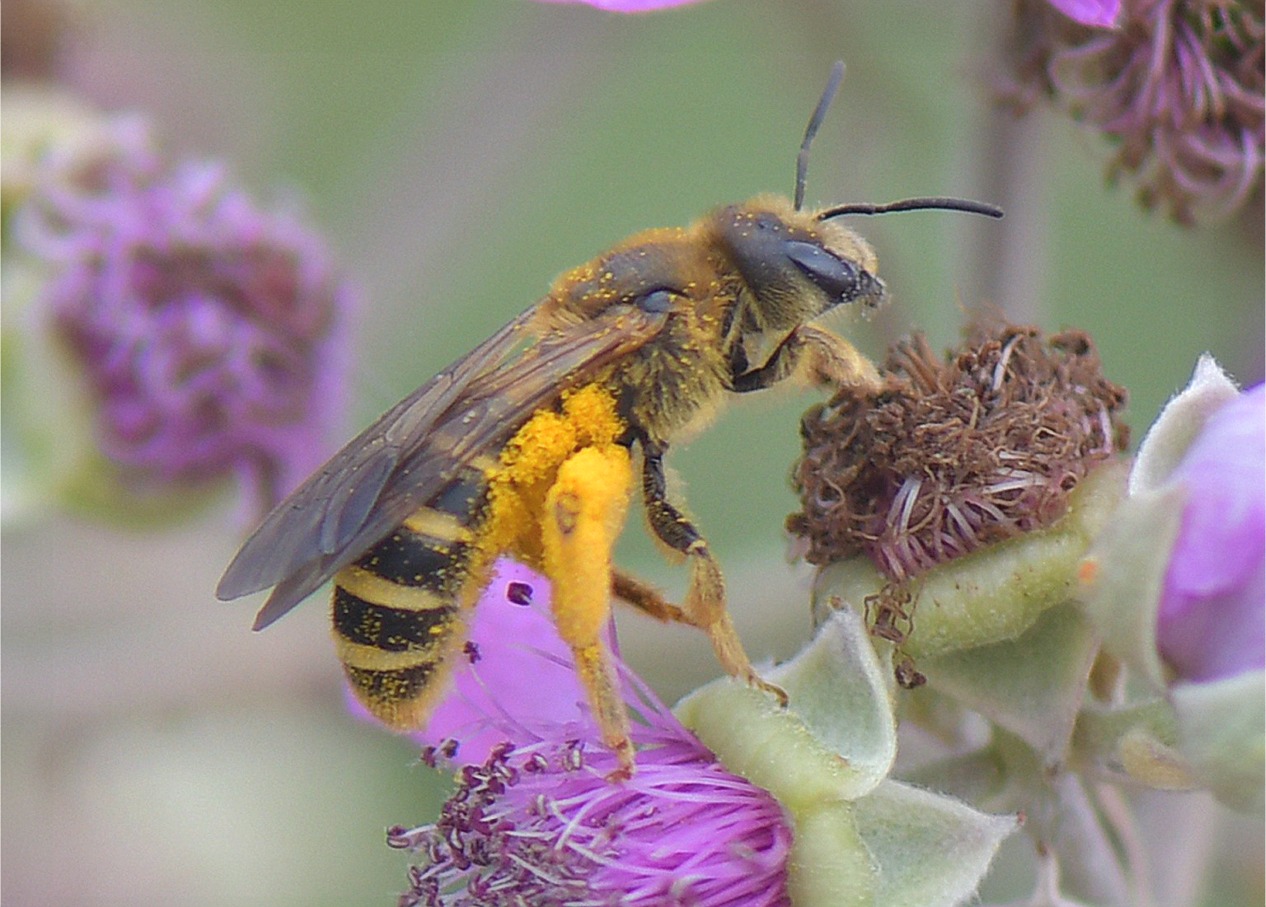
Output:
[541, 445, 634, 780]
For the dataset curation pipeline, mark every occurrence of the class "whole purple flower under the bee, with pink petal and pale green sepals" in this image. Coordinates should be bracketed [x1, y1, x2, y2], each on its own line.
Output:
[387, 560, 1015, 907]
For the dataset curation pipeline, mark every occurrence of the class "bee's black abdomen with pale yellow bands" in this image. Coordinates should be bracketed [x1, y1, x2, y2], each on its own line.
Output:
[333, 467, 487, 730]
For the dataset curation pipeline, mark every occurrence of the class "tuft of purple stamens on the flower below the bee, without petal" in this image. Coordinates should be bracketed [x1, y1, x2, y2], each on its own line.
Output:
[387, 729, 791, 907]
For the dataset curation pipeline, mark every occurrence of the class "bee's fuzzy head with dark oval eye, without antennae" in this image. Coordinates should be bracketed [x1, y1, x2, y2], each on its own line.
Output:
[711, 196, 886, 332]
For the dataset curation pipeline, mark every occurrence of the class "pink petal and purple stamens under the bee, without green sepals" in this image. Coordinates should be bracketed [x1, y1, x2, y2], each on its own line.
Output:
[387, 561, 791, 907]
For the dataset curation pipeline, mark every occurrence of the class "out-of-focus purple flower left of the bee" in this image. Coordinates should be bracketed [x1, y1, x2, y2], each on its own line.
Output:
[18, 119, 352, 505]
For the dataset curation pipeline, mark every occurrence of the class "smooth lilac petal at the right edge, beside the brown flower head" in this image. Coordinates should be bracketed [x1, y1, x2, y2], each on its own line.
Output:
[1157, 384, 1266, 680]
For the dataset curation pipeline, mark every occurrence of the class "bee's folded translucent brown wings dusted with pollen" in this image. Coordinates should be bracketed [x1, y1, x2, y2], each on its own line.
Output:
[216, 309, 666, 630]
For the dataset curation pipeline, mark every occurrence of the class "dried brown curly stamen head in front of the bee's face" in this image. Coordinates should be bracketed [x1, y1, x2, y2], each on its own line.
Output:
[787, 326, 1127, 583]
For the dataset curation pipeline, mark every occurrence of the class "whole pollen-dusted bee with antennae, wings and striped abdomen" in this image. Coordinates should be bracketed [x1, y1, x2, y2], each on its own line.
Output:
[216, 65, 1000, 778]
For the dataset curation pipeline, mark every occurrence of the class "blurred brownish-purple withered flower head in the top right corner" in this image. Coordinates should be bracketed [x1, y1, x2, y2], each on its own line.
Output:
[1009, 0, 1266, 223]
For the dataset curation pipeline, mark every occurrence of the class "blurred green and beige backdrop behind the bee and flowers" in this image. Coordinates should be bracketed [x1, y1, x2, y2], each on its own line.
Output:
[3, 0, 1263, 907]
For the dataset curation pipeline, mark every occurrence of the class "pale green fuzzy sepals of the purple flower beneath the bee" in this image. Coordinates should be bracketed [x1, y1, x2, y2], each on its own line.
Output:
[676, 611, 1019, 907]
